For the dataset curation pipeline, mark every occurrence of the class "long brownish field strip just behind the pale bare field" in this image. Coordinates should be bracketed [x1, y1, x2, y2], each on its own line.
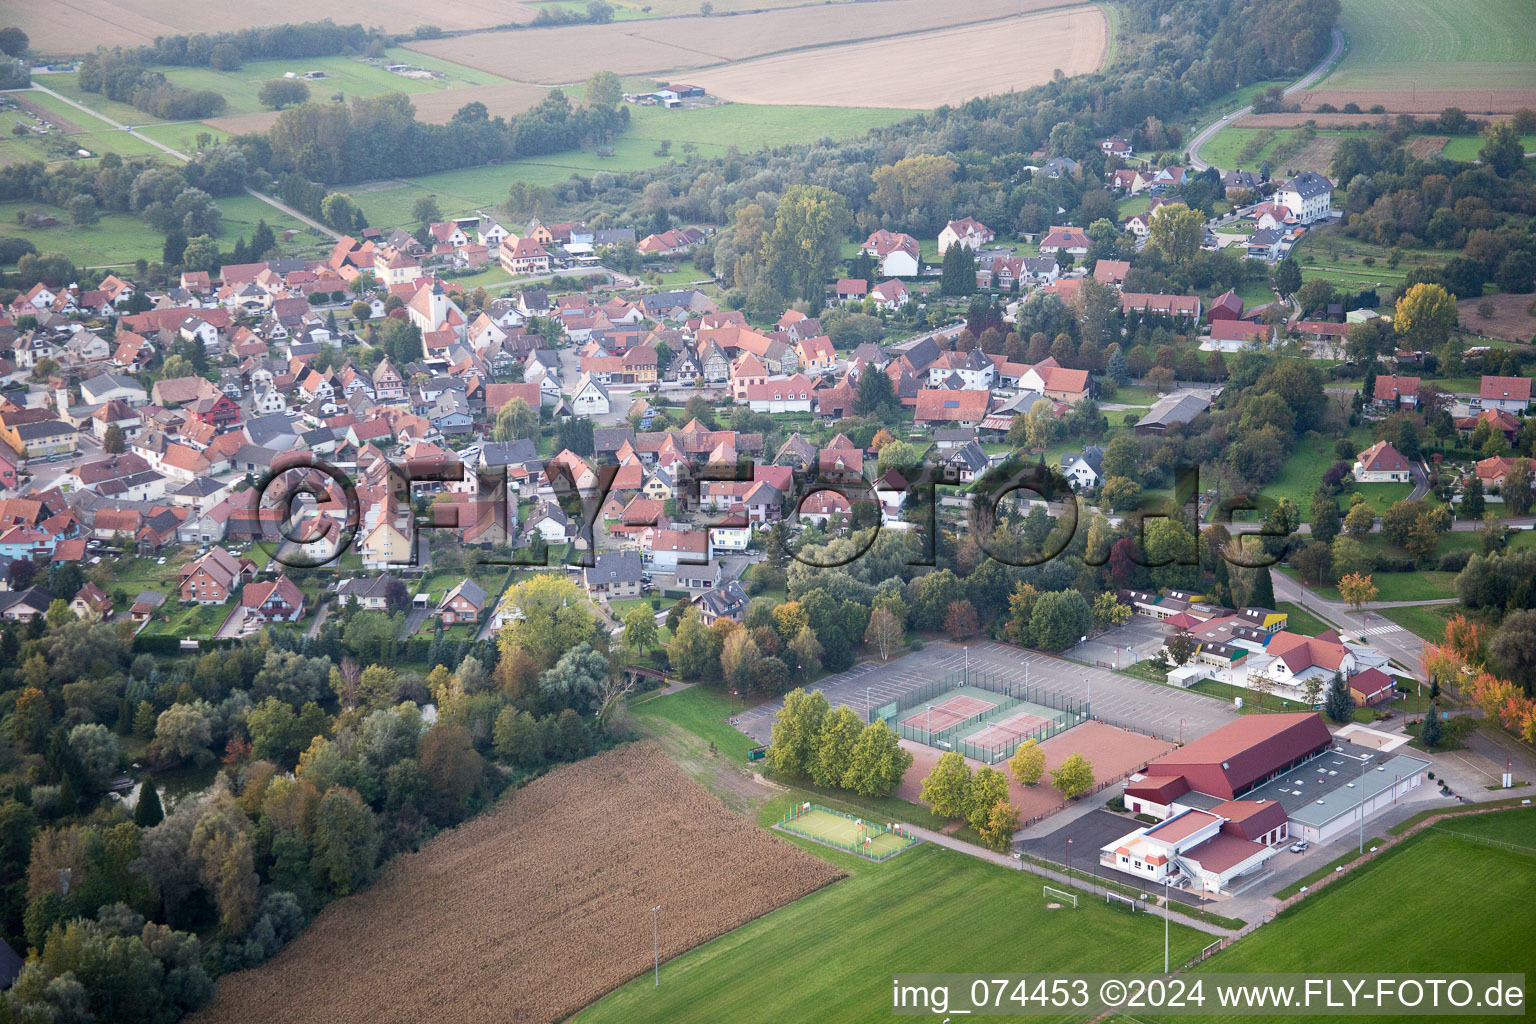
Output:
[409, 0, 1075, 85]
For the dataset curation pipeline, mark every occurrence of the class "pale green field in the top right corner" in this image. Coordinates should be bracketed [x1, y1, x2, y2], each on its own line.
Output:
[1316, 0, 1536, 89]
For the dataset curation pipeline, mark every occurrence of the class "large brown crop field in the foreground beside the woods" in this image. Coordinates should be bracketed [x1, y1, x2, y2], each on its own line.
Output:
[187, 743, 842, 1024]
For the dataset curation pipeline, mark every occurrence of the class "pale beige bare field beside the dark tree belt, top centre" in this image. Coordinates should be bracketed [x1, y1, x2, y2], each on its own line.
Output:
[690, 5, 1107, 109]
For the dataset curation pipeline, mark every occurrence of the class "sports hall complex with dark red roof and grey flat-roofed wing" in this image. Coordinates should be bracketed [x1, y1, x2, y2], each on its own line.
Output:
[1100, 711, 1430, 892]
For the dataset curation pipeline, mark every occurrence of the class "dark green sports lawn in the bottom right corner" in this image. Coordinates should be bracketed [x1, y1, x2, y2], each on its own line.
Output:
[1161, 809, 1536, 1021]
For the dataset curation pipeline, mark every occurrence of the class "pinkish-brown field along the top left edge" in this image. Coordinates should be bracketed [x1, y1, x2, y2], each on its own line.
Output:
[6, 0, 536, 54]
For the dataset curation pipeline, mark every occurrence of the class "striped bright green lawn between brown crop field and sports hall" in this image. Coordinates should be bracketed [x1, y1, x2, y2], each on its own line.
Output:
[576, 844, 1209, 1024]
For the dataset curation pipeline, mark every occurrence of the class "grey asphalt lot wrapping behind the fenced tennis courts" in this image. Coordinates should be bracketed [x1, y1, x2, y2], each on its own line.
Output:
[736, 640, 1236, 743]
